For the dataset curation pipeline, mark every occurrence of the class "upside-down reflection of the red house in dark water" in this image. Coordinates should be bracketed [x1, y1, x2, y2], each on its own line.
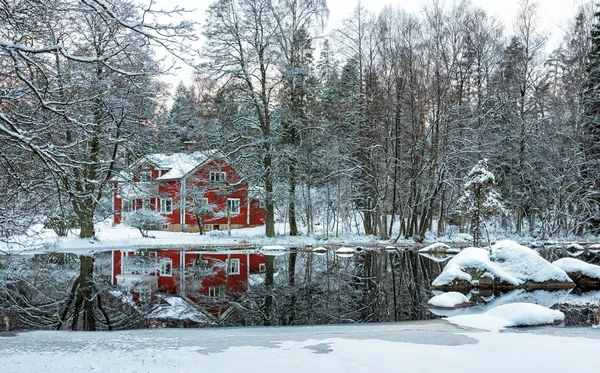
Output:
[111, 249, 266, 321]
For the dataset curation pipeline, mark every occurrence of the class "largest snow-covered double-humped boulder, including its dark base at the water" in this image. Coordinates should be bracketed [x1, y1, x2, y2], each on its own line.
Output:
[432, 241, 574, 290]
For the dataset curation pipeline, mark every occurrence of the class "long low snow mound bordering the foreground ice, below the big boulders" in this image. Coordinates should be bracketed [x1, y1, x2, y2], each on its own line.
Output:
[447, 303, 565, 330]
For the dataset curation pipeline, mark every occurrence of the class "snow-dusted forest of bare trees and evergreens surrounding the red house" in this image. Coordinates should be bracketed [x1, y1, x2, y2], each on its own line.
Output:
[0, 0, 600, 241]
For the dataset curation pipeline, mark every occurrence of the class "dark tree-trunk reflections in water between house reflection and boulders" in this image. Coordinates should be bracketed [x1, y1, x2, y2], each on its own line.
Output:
[234, 250, 442, 325]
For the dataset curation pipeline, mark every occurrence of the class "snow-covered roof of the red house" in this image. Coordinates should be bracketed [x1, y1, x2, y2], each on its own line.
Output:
[143, 149, 225, 180]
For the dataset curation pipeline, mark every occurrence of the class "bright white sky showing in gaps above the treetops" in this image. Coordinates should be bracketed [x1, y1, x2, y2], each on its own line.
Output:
[157, 0, 586, 90]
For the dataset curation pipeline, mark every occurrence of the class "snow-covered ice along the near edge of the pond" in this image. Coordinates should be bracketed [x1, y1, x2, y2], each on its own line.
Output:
[0, 321, 600, 373]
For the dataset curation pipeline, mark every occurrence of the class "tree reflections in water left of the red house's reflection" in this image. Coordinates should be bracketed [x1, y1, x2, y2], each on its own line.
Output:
[0, 253, 150, 331]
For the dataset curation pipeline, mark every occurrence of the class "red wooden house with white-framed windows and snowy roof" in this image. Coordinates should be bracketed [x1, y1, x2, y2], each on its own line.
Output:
[113, 150, 265, 232]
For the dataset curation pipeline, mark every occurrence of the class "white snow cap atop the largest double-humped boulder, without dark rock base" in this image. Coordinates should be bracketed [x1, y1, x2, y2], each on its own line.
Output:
[432, 241, 571, 286]
